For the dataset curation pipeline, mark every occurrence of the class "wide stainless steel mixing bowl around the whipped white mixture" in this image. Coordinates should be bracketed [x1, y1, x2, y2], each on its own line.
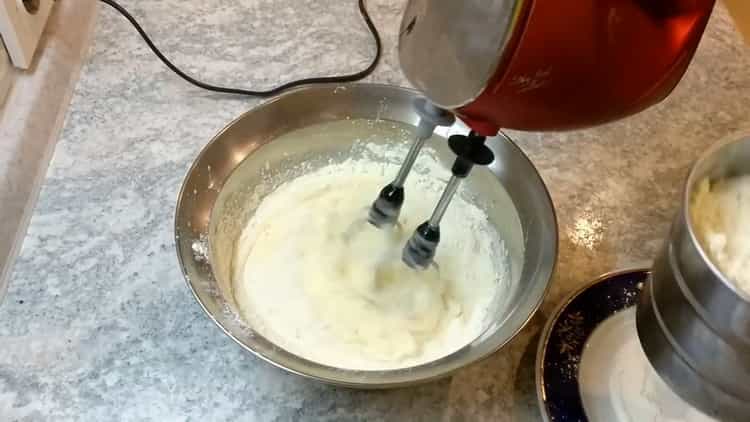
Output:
[175, 84, 557, 388]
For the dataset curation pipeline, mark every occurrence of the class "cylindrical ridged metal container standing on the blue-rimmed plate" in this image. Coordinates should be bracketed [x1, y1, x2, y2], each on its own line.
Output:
[636, 138, 750, 421]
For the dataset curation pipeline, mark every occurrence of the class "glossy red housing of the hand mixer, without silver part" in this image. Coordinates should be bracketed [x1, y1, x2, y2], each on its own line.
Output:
[456, 0, 715, 136]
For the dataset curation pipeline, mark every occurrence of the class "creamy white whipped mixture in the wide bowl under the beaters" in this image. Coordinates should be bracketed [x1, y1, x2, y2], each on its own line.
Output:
[233, 144, 508, 370]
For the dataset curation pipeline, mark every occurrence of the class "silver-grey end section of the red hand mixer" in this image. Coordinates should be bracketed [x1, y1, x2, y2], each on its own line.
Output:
[398, 0, 528, 109]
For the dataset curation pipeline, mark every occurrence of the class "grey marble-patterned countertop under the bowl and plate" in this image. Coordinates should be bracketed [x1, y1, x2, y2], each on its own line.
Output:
[0, 0, 750, 421]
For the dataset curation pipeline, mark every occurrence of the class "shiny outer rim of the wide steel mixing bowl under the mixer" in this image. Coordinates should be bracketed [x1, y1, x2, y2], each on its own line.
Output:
[173, 82, 560, 389]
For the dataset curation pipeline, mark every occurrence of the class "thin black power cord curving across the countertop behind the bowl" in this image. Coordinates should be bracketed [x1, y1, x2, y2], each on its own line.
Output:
[99, 0, 381, 97]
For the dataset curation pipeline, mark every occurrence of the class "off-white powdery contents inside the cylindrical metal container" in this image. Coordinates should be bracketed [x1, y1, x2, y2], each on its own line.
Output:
[690, 175, 750, 298]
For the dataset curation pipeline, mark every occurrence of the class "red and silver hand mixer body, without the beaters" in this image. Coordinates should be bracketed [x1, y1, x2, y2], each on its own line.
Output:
[399, 0, 715, 136]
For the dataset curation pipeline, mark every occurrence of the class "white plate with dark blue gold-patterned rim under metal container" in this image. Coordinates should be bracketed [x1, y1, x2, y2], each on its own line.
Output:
[536, 269, 714, 422]
